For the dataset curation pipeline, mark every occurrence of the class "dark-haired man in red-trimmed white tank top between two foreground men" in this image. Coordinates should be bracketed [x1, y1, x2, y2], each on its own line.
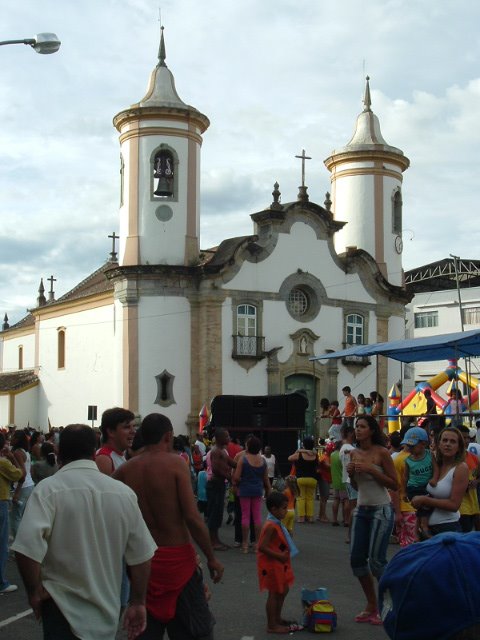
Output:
[95, 407, 135, 476]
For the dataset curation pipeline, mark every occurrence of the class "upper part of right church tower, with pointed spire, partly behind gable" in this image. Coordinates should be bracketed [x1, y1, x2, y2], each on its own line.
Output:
[325, 76, 410, 285]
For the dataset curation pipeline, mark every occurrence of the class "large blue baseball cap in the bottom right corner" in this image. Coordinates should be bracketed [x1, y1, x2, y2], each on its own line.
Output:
[379, 532, 480, 640]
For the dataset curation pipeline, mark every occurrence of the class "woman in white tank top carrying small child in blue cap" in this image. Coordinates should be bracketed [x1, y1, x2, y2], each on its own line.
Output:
[412, 427, 468, 535]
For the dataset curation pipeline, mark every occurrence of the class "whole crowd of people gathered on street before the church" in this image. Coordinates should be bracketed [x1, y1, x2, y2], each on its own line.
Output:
[0, 387, 480, 640]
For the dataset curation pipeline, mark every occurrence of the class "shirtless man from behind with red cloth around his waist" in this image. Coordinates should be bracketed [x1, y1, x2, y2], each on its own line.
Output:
[113, 413, 223, 640]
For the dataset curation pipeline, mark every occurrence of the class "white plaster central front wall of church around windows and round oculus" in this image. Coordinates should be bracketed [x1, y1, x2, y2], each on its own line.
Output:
[218, 222, 404, 400]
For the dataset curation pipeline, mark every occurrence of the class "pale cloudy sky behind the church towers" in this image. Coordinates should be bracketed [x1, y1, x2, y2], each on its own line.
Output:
[0, 0, 480, 322]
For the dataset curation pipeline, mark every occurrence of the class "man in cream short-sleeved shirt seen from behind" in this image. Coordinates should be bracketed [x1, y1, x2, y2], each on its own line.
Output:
[12, 425, 157, 640]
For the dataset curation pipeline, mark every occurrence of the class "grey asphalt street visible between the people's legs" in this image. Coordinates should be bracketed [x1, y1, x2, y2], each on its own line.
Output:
[0, 504, 398, 640]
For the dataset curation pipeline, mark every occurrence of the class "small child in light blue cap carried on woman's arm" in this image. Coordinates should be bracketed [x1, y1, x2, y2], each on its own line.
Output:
[400, 427, 438, 539]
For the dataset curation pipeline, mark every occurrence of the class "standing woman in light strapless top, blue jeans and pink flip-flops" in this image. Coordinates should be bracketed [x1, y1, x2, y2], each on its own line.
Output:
[347, 415, 398, 625]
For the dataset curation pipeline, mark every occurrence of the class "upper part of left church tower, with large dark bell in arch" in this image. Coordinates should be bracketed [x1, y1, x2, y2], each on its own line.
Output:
[113, 27, 210, 266]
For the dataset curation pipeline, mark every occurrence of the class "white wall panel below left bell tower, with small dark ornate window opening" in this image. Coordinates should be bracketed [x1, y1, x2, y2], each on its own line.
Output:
[138, 296, 191, 433]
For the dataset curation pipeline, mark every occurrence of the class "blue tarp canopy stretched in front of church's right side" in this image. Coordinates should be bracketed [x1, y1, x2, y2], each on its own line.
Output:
[310, 329, 480, 362]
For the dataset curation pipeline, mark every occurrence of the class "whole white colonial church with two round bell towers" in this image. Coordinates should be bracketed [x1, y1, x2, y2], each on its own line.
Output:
[0, 32, 411, 433]
